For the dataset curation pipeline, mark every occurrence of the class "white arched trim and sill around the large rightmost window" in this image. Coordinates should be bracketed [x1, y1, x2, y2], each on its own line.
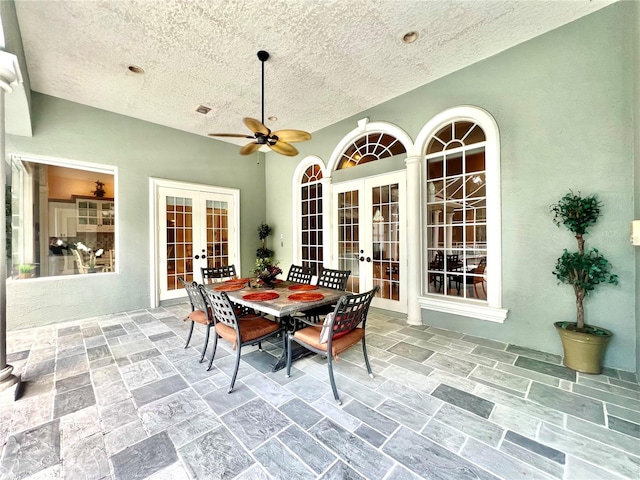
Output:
[413, 105, 508, 323]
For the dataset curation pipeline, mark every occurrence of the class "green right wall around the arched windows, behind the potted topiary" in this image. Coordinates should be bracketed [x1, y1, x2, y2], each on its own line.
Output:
[266, 2, 640, 371]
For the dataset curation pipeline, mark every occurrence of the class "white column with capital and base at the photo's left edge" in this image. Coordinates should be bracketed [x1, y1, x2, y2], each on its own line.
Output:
[0, 51, 22, 400]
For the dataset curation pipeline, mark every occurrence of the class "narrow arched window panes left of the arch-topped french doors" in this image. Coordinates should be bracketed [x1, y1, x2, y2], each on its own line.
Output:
[300, 164, 323, 275]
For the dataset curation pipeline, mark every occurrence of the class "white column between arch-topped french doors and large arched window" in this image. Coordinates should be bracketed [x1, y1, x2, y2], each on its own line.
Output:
[402, 156, 423, 325]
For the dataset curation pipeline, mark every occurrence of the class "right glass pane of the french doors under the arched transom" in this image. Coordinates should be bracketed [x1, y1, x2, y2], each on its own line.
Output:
[371, 183, 400, 301]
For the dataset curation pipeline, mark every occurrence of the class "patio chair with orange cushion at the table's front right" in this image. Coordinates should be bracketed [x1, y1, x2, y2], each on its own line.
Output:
[286, 286, 380, 405]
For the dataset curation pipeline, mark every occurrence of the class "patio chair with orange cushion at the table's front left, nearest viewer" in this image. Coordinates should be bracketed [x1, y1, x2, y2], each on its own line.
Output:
[200, 285, 285, 393]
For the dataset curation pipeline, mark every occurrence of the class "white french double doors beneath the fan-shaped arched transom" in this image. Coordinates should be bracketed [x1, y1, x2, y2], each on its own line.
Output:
[332, 172, 407, 313]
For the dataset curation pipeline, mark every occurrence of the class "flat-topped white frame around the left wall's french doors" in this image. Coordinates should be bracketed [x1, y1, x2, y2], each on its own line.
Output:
[149, 177, 241, 308]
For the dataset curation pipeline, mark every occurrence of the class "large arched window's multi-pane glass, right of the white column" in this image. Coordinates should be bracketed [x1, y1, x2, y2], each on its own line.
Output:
[426, 121, 489, 301]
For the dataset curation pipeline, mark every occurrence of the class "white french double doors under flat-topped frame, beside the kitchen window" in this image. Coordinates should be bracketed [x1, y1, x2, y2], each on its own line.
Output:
[156, 182, 239, 300]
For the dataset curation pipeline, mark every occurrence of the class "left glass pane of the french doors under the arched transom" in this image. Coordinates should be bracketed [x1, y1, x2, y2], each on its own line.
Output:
[338, 191, 360, 292]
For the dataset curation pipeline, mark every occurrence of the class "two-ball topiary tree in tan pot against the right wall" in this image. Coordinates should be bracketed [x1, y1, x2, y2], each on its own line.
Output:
[551, 191, 618, 374]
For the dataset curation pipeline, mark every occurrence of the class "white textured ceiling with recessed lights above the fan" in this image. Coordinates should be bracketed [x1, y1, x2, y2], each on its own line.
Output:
[15, 0, 613, 143]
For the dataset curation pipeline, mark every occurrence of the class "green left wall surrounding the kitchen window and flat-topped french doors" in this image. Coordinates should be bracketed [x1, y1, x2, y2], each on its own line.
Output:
[6, 93, 265, 329]
